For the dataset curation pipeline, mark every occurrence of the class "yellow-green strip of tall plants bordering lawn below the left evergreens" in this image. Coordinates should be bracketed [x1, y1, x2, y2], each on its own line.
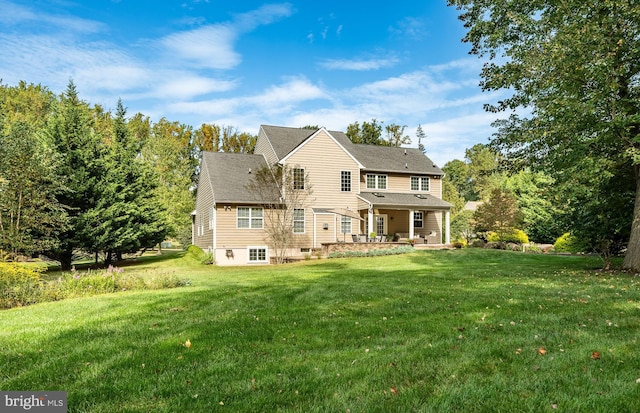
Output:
[0, 262, 190, 308]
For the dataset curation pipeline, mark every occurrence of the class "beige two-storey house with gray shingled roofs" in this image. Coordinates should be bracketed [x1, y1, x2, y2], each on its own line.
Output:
[193, 125, 451, 265]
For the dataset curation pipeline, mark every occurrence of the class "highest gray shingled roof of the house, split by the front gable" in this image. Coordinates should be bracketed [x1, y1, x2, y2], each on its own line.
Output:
[261, 125, 444, 175]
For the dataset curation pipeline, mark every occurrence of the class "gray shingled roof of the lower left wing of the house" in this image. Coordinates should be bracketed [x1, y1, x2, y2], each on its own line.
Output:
[202, 152, 274, 203]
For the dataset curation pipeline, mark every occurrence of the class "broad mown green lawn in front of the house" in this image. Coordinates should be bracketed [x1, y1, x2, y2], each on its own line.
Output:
[0, 250, 640, 412]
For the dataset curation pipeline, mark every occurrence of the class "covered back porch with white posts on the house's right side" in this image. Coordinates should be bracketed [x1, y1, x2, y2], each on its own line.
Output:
[358, 192, 452, 245]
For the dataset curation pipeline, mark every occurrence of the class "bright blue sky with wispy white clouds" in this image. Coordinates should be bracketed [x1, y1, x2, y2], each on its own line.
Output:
[0, 0, 504, 166]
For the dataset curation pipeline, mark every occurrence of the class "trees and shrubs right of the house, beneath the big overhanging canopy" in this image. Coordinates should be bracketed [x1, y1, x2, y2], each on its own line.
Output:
[442, 144, 634, 261]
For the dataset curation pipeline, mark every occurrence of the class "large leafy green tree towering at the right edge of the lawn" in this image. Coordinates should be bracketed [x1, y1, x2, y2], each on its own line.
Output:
[448, 0, 640, 271]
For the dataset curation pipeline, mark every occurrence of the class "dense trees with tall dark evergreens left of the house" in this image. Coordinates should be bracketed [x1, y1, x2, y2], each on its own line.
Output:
[0, 82, 256, 269]
